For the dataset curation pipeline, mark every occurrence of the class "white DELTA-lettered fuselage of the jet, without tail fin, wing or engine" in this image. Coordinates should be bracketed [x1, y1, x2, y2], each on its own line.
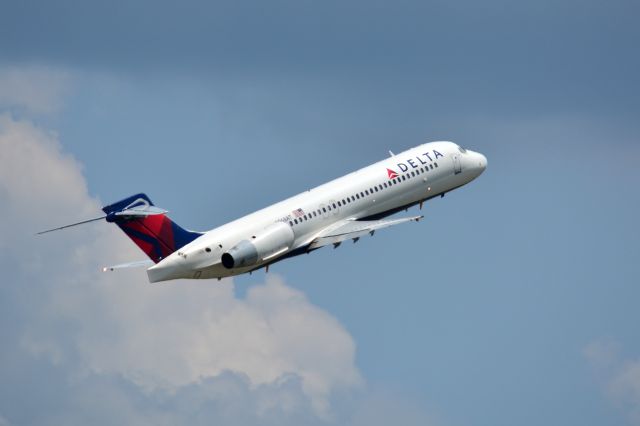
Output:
[147, 142, 487, 282]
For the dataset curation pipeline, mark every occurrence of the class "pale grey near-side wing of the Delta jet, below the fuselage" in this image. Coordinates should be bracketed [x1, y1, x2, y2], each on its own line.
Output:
[309, 216, 424, 249]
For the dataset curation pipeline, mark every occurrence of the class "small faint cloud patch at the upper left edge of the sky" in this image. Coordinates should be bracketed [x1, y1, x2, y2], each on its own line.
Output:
[0, 66, 70, 114]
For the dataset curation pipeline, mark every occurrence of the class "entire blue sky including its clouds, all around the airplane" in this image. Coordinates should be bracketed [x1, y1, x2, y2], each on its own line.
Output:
[0, 0, 640, 425]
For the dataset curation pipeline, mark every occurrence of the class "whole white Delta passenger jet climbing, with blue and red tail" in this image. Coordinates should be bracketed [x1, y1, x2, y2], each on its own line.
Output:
[38, 141, 487, 283]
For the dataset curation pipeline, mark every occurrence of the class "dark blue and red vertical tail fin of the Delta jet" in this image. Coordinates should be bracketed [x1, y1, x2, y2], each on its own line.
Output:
[102, 194, 202, 263]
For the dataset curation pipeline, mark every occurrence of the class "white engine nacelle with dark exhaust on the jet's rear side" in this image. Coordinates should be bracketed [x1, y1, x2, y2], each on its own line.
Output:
[222, 222, 294, 269]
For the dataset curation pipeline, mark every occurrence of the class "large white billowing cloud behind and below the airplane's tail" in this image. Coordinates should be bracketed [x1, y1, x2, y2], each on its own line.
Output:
[0, 114, 361, 423]
